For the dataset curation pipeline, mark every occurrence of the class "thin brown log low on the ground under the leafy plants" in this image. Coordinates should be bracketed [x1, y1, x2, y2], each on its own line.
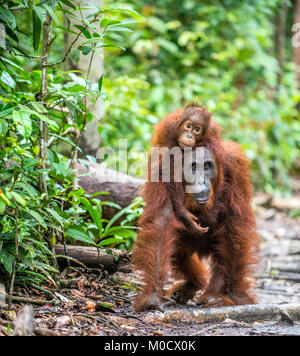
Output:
[54, 245, 130, 273]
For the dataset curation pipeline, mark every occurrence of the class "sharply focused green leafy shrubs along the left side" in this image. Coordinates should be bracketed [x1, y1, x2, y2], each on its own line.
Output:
[0, 0, 141, 283]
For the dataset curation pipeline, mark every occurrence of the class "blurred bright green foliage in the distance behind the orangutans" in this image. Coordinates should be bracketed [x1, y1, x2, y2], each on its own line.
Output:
[105, 0, 300, 193]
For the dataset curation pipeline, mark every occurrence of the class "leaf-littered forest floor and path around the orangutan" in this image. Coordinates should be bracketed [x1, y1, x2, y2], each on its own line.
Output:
[0, 193, 300, 336]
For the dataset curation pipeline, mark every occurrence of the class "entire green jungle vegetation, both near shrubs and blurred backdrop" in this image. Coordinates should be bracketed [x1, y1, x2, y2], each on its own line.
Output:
[0, 0, 300, 336]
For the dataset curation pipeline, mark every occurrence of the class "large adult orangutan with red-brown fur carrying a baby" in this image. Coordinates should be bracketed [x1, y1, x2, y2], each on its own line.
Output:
[133, 105, 259, 311]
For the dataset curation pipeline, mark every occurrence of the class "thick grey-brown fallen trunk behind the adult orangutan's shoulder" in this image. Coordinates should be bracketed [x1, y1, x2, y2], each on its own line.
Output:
[77, 161, 145, 219]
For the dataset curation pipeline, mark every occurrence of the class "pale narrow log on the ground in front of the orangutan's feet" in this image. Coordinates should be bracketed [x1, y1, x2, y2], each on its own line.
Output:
[146, 304, 300, 323]
